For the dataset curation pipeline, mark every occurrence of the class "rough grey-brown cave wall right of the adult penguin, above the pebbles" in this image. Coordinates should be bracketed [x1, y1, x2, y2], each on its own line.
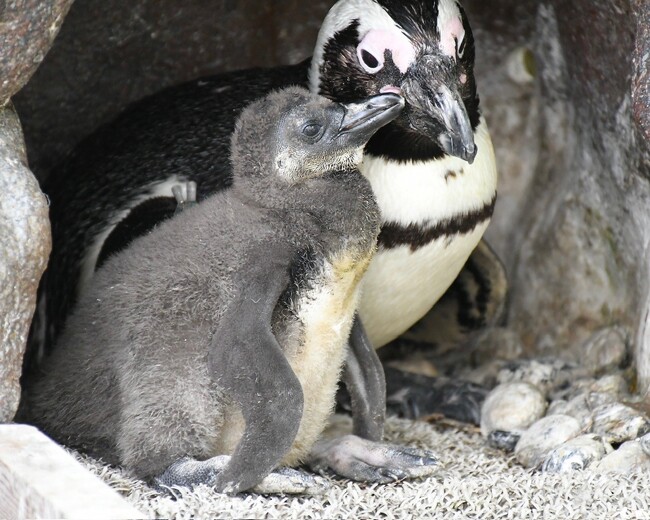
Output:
[466, 0, 650, 386]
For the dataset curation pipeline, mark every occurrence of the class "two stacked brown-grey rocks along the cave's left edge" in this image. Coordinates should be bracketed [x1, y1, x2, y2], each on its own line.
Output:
[0, 0, 71, 423]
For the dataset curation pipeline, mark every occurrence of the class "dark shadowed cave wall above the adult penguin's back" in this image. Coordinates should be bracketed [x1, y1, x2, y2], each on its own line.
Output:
[16, 0, 334, 177]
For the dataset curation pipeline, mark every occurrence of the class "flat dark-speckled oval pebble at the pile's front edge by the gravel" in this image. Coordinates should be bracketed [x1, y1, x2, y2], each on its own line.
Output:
[542, 434, 613, 473]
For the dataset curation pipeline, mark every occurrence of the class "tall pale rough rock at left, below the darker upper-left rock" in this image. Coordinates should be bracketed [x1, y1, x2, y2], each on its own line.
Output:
[0, 105, 51, 423]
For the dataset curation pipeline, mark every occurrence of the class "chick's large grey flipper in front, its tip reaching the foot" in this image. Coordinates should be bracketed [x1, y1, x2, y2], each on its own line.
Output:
[208, 256, 304, 493]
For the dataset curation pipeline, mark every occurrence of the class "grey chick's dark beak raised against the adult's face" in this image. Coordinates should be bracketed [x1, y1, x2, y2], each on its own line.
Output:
[335, 94, 404, 146]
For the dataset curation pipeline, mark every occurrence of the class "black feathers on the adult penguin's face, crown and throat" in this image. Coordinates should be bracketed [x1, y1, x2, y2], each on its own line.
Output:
[319, 0, 480, 161]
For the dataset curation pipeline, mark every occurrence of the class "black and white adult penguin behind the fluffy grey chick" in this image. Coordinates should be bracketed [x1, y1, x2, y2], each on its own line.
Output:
[35, 0, 497, 416]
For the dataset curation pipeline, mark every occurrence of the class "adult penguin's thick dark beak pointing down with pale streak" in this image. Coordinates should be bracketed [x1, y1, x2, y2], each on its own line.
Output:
[402, 56, 477, 164]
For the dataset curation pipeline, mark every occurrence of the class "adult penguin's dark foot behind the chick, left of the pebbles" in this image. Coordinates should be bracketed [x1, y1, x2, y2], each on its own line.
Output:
[385, 367, 488, 424]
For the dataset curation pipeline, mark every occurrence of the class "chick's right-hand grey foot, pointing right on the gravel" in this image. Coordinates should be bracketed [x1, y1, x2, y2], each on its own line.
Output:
[308, 435, 438, 484]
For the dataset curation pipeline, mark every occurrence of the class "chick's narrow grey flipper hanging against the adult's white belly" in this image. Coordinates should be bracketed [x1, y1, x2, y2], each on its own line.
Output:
[343, 315, 386, 441]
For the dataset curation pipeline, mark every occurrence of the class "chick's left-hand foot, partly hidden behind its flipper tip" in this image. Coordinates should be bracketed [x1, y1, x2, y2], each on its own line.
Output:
[153, 455, 330, 495]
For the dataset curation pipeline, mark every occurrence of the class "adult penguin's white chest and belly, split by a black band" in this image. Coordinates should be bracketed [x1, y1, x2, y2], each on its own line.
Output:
[359, 120, 497, 347]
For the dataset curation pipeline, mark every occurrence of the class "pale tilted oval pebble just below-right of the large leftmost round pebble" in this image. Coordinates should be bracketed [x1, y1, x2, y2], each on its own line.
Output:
[515, 415, 580, 468]
